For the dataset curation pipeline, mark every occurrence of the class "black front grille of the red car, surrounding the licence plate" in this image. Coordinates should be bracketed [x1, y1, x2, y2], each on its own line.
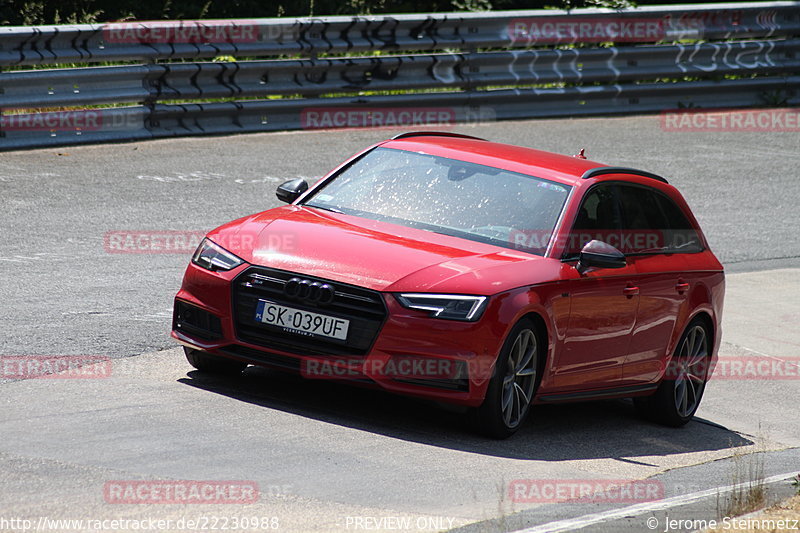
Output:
[233, 266, 387, 355]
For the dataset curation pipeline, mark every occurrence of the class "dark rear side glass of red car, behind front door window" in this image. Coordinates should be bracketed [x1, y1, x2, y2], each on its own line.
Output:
[618, 185, 703, 254]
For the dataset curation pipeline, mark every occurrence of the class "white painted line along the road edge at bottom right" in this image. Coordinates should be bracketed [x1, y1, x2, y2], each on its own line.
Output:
[519, 472, 797, 533]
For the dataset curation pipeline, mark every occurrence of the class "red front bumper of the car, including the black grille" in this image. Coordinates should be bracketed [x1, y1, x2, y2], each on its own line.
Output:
[172, 263, 502, 406]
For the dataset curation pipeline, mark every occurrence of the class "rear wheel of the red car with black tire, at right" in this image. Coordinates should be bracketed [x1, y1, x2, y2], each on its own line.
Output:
[633, 319, 711, 427]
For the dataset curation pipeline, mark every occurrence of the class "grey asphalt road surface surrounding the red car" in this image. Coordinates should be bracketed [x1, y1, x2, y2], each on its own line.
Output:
[0, 117, 800, 531]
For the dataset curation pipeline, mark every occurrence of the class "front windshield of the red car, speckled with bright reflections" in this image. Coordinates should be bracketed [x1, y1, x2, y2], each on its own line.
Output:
[304, 144, 570, 255]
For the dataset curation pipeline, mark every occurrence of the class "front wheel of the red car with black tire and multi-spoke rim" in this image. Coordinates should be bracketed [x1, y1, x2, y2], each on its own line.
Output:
[475, 318, 545, 439]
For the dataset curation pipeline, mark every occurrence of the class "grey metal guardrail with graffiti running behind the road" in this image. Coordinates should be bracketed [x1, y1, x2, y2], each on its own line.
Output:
[0, 1, 800, 149]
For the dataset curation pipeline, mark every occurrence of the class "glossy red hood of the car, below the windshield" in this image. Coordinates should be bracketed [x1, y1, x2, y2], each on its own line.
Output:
[208, 205, 562, 294]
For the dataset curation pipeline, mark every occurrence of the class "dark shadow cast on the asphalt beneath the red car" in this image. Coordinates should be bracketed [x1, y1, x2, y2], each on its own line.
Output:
[178, 366, 753, 465]
